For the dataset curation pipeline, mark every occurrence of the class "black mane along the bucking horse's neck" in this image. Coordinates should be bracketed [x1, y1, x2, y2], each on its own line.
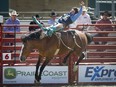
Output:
[21, 30, 42, 42]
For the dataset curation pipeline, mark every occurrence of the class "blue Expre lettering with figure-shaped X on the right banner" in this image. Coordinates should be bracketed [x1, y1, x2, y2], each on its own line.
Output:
[85, 66, 116, 81]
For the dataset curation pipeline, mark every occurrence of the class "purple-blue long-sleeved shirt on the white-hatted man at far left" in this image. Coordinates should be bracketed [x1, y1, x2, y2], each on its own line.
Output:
[4, 18, 20, 32]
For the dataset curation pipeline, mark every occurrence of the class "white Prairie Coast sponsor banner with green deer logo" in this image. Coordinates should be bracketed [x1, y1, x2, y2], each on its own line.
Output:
[3, 66, 68, 84]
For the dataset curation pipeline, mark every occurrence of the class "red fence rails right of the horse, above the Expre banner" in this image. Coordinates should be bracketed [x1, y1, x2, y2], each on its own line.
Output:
[78, 24, 116, 64]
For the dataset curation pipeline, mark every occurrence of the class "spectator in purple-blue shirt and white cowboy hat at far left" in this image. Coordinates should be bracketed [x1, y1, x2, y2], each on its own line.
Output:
[3, 10, 20, 45]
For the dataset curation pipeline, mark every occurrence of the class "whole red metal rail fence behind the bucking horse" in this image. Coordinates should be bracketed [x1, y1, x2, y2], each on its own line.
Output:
[0, 24, 116, 85]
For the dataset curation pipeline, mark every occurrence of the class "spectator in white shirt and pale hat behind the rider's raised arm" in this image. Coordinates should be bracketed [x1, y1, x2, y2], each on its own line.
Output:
[75, 6, 91, 31]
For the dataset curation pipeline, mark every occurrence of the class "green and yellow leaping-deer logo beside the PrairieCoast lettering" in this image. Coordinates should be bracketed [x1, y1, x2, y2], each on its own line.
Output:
[4, 68, 16, 79]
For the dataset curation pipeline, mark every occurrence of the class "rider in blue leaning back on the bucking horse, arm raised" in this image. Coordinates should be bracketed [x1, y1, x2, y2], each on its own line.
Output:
[33, 1, 84, 36]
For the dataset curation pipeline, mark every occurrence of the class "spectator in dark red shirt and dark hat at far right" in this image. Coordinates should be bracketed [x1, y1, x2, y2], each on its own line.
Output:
[95, 11, 113, 44]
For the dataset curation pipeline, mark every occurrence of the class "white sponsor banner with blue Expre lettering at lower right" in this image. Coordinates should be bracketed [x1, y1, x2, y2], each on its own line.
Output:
[78, 65, 116, 82]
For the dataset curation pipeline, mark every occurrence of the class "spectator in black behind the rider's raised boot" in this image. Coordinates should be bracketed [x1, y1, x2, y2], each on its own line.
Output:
[29, 14, 43, 32]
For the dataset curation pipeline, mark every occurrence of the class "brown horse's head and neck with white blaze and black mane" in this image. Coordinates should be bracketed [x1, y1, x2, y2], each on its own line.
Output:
[19, 31, 41, 62]
